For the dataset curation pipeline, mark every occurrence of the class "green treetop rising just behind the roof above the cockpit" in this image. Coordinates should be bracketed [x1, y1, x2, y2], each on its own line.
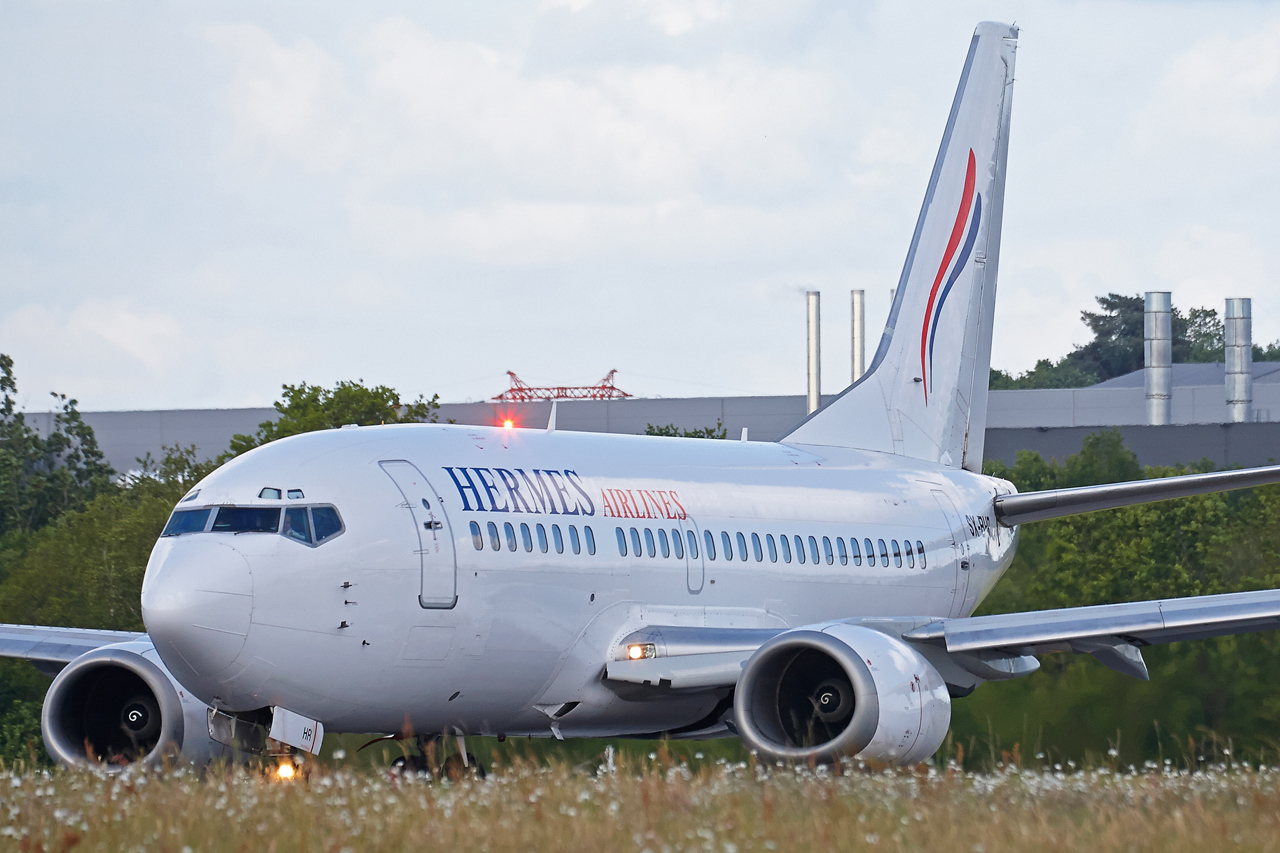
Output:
[224, 382, 440, 459]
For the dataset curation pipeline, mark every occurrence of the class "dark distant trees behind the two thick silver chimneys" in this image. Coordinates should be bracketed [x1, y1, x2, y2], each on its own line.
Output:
[991, 293, 1280, 391]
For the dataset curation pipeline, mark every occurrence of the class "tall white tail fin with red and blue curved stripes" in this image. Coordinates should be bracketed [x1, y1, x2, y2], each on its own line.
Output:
[782, 23, 1018, 471]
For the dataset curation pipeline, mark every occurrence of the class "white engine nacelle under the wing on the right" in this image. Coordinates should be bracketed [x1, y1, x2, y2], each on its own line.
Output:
[733, 622, 951, 765]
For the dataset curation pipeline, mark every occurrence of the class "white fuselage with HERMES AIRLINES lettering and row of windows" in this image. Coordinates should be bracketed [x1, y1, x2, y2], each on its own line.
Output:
[142, 425, 1016, 736]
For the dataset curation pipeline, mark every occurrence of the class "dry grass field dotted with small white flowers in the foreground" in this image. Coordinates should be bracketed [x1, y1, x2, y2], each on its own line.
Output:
[0, 747, 1280, 853]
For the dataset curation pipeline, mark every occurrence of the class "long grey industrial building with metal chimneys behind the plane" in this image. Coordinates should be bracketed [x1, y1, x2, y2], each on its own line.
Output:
[28, 291, 1280, 471]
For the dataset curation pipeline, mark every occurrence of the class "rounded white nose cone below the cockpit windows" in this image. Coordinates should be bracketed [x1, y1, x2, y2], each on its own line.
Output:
[142, 535, 253, 679]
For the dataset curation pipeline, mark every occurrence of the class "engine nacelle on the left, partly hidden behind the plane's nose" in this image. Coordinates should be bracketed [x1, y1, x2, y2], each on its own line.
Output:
[40, 640, 234, 768]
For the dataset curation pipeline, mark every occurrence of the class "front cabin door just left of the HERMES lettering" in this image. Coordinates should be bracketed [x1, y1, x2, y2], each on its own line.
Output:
[378, 459, 458, 610]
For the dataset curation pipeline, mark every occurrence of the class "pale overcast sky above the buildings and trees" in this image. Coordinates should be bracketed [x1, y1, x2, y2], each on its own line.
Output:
[0, 0, 1280, 410]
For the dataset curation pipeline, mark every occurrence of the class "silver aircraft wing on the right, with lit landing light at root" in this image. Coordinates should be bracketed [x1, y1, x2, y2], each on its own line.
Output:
[605, 589, 1280, 689]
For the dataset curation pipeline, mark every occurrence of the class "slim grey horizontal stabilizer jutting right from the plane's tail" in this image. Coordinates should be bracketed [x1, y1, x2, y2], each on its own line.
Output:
[996, 465, 1280, 528]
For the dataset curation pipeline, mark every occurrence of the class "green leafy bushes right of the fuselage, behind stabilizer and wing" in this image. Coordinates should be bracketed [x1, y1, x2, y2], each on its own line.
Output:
[952, 430, 1280, 763]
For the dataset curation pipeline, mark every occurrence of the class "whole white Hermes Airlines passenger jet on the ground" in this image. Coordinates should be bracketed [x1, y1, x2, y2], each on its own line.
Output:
[10, 23, 1280, 765]
